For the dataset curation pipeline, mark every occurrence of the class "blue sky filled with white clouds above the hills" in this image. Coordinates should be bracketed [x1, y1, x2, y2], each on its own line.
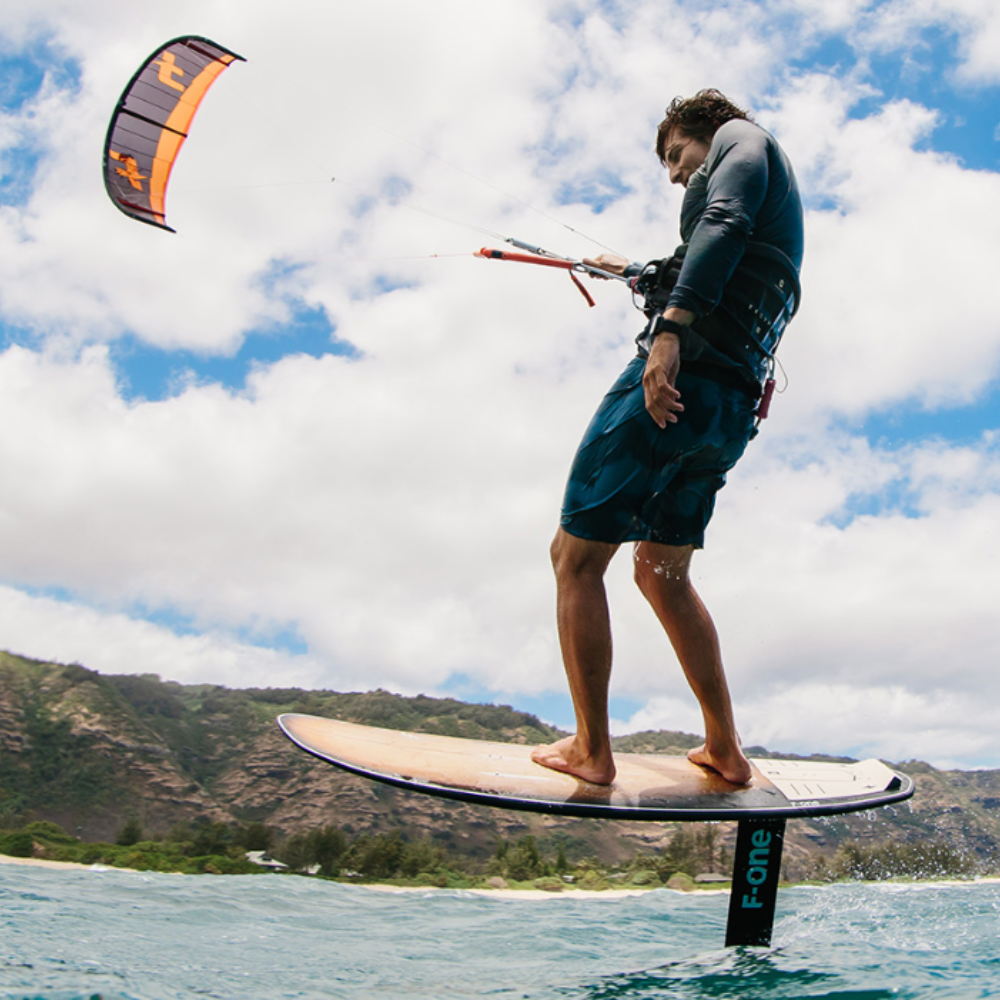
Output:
[0, 0, 1000, 768]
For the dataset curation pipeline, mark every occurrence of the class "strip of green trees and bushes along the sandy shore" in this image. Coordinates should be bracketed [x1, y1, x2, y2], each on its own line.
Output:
[0, 819, 984, 898]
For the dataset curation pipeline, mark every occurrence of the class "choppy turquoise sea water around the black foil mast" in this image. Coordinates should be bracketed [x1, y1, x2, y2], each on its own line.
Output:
[0, 865, 1000, 1000]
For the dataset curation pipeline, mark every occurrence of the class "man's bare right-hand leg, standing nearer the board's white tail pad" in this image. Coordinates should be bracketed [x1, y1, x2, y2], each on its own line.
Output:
[635, 542, 751, 785]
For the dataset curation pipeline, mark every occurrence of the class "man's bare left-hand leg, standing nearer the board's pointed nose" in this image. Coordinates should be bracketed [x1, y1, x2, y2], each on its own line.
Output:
[531, 528, 618, 785]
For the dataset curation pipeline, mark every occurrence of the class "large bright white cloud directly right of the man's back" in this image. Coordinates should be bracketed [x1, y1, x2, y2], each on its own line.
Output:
[760, 95, 1000, 417]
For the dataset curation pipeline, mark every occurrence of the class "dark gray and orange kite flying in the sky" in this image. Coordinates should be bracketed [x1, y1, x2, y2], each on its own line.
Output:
[104, 35, 246, 233]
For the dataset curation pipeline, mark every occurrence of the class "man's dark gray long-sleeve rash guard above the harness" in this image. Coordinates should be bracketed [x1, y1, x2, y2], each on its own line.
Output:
[668, 119, 804, 316]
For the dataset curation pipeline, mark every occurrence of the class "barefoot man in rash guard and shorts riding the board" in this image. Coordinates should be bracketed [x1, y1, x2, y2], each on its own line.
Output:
[532, 90, 803, 784]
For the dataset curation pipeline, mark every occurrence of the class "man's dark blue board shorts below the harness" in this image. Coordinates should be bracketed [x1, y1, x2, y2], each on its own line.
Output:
[560, 357, 757, 549]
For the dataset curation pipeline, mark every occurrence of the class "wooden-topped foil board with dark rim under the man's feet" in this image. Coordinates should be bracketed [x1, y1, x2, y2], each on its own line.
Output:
[278, 714, 914, 820]
